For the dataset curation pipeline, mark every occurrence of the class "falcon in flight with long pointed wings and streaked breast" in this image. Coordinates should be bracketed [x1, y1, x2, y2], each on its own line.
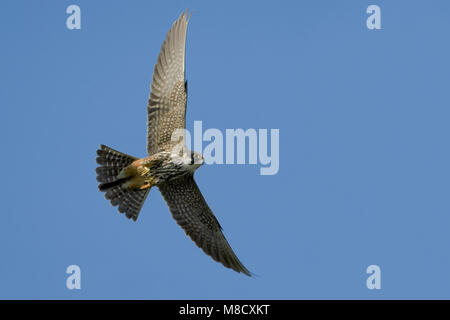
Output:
[96, 11, 251, 276]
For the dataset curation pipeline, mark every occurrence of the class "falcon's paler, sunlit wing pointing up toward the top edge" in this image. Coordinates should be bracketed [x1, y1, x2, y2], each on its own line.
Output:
[147, 11, 189, 155]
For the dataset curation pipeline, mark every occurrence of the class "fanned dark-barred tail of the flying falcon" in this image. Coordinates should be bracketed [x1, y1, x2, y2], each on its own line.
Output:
[95, 145, 150, 221]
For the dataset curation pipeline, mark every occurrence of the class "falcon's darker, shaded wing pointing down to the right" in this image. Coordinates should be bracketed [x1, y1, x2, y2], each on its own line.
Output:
[159, 175, 250, 276]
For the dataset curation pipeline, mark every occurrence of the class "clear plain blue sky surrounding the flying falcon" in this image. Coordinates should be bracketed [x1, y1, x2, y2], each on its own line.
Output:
[0, 0, 450, 299]
